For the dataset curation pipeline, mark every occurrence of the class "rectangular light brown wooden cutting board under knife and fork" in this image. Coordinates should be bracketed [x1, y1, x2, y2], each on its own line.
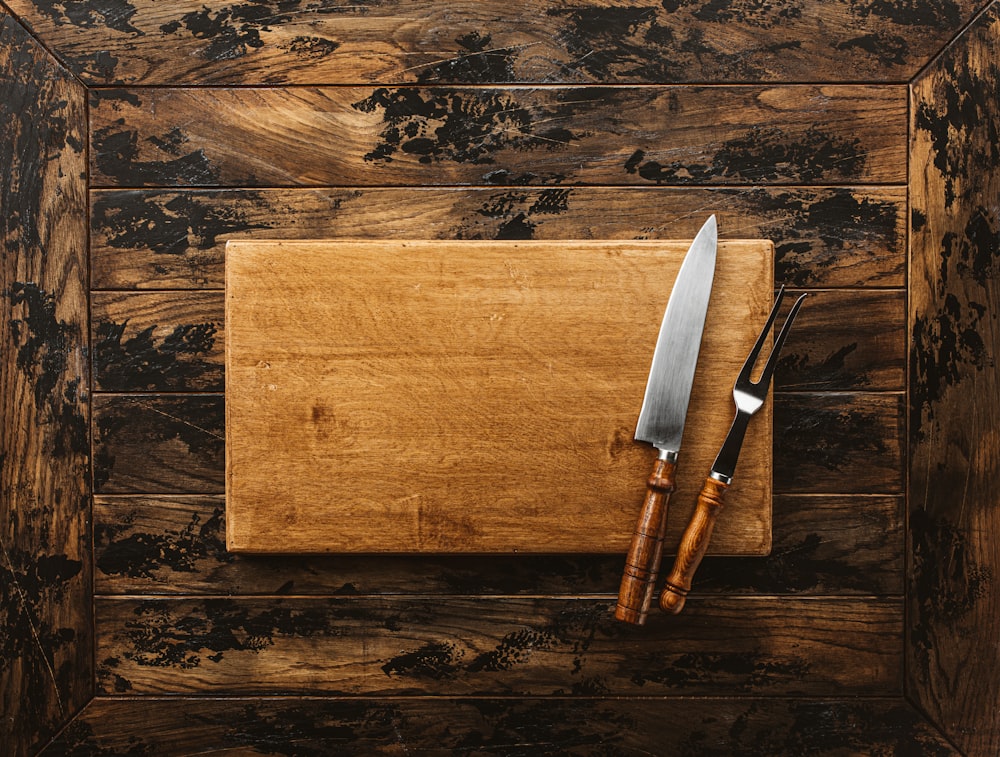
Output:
[226, 240, 773, 556]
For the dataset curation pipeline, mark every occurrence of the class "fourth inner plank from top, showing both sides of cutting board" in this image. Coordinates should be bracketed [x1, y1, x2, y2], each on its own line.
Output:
[93, 392, 903, 494]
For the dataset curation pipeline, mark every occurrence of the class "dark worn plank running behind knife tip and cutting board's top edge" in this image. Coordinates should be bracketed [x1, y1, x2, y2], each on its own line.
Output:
[91, 186, 906, 289]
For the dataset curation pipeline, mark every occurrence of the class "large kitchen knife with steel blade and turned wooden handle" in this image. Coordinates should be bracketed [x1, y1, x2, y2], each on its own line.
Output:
[615, 215, 718, 625]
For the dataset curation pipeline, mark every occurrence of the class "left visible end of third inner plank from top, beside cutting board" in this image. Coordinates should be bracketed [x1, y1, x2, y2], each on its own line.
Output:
[91, 292, 225, 392]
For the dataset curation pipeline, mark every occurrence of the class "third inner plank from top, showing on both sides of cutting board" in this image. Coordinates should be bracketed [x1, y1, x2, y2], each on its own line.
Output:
[91, 289, 906, 392]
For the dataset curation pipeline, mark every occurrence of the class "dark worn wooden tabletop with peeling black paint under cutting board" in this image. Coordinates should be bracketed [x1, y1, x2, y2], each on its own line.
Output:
[0, 0, 1000, 757]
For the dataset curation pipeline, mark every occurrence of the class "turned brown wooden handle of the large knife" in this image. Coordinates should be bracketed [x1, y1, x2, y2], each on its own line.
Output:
[615, 458, 677, 626]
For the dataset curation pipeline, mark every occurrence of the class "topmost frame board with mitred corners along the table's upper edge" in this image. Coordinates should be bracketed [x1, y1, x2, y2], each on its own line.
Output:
[9, 0, 980, 85]
